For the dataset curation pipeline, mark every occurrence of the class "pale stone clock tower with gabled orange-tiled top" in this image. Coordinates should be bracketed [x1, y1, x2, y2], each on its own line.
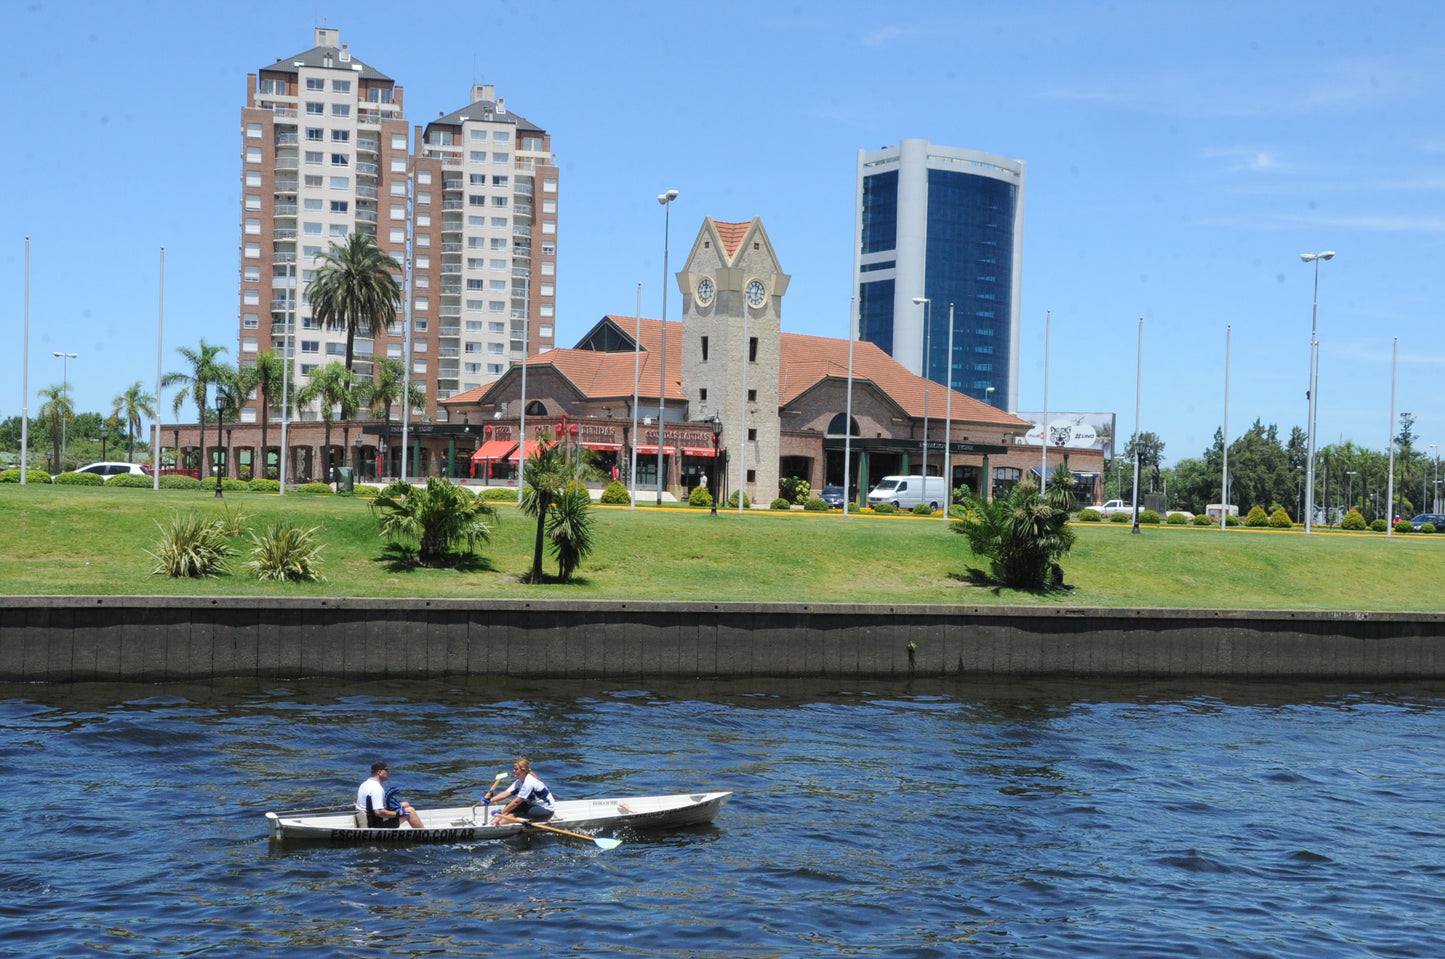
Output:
[678, 217, 790, 505]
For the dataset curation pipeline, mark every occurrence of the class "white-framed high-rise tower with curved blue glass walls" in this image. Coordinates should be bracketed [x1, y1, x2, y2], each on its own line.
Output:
[853, 140, 1025, 410]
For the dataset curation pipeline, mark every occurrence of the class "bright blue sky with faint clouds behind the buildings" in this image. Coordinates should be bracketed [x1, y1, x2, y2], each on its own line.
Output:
[0, 0, 1445, 462]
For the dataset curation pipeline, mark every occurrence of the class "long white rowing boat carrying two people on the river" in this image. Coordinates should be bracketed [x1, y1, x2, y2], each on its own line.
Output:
[266, 793, 733, 842]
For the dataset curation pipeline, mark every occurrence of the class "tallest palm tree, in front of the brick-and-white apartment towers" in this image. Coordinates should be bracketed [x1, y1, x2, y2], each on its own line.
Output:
[306, 233, 402, 370]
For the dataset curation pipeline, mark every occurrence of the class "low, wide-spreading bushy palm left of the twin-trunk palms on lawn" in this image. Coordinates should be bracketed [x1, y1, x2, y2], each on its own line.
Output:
[371, 477, 497, 566]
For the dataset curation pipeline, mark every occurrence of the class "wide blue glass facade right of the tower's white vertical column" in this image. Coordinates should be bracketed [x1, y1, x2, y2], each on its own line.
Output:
[923, 169, 1019, 400]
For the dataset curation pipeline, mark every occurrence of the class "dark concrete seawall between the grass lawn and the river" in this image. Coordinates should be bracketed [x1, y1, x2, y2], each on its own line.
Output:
[0, 596, 1445, 683]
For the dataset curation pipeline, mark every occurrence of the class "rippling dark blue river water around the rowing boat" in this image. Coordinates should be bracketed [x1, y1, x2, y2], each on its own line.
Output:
[0, 682, 1445, 959]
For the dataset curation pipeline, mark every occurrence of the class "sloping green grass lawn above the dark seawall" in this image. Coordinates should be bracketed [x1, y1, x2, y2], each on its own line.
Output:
[0, 484, 1445, 611]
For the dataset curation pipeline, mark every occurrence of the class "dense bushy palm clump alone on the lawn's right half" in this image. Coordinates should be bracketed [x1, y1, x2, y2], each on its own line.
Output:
[952, 467, 1074, 589]
